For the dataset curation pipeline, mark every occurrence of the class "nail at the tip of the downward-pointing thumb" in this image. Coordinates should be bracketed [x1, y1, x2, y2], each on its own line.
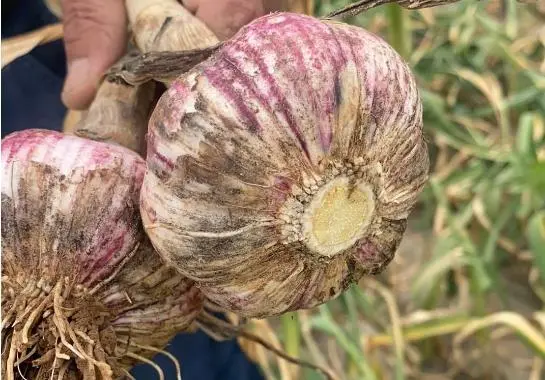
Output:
[61, 58, 95, 109]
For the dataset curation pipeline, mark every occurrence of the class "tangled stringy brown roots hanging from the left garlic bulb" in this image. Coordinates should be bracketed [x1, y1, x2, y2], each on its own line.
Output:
[2, 279, 113, 379]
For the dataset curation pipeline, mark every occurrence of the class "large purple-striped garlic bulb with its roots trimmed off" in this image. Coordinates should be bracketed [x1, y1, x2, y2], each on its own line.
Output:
[141, 13, 429, 318]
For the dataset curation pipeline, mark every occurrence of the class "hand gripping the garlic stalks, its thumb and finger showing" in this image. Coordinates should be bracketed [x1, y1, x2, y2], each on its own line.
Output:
[61, 0, 266, 109]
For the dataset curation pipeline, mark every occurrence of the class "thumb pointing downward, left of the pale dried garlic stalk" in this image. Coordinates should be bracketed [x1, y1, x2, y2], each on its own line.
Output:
[61, 0, 127, 109]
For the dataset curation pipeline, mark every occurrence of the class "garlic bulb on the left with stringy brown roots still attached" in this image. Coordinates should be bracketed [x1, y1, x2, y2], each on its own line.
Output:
[2, 130, 202, 379]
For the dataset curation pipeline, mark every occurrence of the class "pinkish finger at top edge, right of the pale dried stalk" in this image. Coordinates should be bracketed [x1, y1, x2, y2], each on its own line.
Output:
[184, 0, 265, 40]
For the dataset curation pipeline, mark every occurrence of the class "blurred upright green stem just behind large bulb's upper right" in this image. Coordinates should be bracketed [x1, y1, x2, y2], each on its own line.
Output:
[386, 4, 412, 59]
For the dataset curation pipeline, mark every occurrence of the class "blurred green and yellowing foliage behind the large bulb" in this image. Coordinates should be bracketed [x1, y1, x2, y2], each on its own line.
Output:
[240, 0, 545, 379]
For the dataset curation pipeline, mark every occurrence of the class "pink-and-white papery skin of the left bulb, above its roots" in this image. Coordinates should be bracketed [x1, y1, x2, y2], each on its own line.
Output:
[2, 130, 146, 287]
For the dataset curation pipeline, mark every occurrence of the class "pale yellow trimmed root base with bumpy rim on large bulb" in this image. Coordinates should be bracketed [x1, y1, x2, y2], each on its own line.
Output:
[279, 163, 381, 258]
